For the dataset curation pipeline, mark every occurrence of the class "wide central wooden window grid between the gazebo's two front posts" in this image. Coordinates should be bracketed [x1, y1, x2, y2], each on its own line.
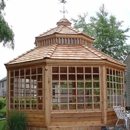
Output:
[51, 66, 101, 111]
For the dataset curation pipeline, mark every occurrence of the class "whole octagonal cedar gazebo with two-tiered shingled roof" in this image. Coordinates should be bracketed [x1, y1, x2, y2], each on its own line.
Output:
[5, 18, 125, 130]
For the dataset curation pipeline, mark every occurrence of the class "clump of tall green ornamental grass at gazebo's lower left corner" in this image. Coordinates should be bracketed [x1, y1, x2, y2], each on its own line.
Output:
[7, 111, 28, 130]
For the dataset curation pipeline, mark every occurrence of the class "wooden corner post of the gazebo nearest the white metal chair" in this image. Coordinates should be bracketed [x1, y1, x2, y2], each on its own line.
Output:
[101, 66, 107, 124]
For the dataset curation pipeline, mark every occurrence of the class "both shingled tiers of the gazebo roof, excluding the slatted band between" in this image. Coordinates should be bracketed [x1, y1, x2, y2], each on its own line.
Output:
[6, 18, 125, 66]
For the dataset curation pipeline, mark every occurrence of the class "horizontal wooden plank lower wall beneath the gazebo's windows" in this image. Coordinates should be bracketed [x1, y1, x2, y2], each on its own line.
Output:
[9, 110, 117, 130]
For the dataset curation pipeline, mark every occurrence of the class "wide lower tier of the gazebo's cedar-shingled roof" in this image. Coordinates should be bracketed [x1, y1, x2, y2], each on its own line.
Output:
[7, 43, 125, 66]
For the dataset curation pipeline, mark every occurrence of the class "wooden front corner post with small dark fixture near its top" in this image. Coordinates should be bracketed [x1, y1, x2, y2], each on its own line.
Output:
[44, 66, 51, 126]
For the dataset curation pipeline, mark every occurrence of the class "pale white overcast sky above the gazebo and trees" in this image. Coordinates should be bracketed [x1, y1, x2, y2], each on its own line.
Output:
[0, 0, 130, 79]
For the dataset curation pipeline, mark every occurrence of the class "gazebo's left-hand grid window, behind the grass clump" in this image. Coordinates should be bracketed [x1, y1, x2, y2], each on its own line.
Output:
[9, 66, 44, 110]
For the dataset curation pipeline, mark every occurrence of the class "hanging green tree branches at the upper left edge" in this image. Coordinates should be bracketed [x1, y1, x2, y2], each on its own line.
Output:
[0, 0, 14, 49]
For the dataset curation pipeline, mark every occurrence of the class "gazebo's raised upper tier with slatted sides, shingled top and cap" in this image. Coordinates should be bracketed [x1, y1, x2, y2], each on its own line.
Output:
[35, 18, 94, 47]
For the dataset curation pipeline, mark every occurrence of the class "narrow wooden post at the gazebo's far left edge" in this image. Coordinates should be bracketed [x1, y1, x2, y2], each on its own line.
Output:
[6, 70, 10, 118]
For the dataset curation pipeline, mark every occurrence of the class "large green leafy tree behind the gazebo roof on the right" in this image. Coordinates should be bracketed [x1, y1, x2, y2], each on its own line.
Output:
[72, 5, 130, 61]
